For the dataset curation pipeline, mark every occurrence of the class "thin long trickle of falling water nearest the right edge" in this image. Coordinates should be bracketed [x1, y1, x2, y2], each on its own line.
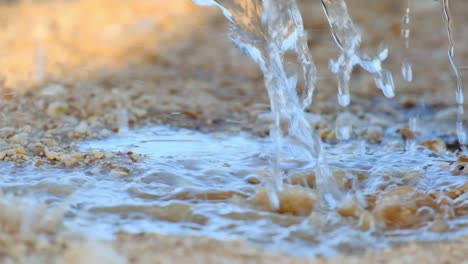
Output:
[443, 0, 467, 152]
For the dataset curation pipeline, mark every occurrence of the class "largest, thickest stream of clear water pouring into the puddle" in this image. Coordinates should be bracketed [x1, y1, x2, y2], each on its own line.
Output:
[194, 0, 339, 208]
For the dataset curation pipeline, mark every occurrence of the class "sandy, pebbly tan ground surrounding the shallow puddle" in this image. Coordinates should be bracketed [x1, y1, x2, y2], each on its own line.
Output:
[0, 0, 468, 263]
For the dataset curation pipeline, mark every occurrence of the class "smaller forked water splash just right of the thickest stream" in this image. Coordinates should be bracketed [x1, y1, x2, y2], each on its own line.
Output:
[321, 0, 395, 106]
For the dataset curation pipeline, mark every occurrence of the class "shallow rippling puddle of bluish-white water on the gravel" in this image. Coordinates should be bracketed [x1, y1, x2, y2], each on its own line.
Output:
[0, 126, 468, 256]
